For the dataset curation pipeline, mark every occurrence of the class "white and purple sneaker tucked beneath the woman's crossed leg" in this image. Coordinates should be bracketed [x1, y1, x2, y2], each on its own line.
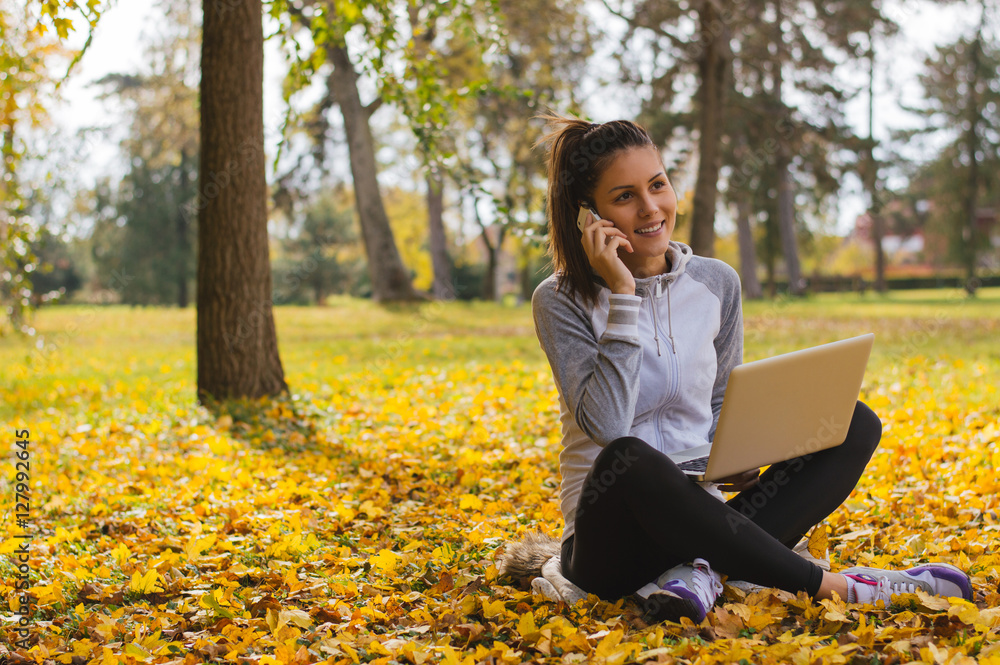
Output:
[644, 559, 722, 623]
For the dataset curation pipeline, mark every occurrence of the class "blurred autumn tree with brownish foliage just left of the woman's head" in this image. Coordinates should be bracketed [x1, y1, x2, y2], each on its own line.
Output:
[448, 0, 591, 300]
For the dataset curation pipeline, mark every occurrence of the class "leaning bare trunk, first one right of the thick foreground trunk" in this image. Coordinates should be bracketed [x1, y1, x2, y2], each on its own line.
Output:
[327, 41, 419, 302]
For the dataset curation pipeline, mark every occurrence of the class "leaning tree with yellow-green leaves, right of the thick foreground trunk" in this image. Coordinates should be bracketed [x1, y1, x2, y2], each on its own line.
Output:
[274, 0, 496, 301]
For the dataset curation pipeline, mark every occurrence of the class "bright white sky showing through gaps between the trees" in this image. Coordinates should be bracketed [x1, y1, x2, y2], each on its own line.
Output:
[53, 0, 978, 233]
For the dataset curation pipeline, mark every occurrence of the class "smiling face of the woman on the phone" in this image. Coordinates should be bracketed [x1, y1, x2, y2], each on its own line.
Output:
[593, 146, 677, 265]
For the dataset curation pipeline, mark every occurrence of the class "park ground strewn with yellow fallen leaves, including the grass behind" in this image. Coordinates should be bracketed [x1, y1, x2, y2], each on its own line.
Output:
[0, 290, 1000, 664]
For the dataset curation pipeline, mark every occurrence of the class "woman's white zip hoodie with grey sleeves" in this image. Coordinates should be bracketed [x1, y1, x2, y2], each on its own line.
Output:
[531, 241, 743, 540]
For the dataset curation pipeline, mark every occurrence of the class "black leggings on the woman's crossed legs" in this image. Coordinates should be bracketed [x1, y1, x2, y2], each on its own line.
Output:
[562, 402, 882, 600]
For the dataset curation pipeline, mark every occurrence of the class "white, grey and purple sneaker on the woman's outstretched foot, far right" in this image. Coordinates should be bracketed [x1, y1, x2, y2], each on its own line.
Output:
[840, 563, 972, 607]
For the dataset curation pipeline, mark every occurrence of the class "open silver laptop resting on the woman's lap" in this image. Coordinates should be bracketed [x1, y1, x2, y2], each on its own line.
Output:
[668, 333, 875, 481]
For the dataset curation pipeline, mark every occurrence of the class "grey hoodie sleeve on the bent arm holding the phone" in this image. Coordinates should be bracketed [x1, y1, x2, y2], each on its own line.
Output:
[531, 279, 642, 447]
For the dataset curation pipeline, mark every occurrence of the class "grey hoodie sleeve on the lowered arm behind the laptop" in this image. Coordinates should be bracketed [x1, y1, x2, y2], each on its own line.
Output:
[688, 259, 743, 441]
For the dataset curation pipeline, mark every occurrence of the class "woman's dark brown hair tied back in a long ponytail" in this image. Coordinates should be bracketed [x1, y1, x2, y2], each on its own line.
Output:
[538, 114, 655, 304]
